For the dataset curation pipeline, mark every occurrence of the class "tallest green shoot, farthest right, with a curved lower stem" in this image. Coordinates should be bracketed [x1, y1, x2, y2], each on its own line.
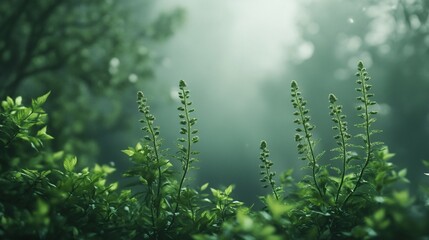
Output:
[343, 61, 380, 206]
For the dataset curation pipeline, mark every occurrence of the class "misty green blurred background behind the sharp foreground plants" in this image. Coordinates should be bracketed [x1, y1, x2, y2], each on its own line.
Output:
[4, 0, 429, 205]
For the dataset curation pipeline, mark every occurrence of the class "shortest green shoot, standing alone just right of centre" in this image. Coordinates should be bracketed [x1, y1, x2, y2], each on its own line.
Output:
[259, 141, 281, 200]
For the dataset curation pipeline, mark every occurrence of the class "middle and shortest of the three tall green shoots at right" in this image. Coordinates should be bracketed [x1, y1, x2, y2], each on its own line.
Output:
[329, 94, 351, 203]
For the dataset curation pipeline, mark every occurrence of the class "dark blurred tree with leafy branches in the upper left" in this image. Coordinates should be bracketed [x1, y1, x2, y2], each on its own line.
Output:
[0, 0, 184, 162]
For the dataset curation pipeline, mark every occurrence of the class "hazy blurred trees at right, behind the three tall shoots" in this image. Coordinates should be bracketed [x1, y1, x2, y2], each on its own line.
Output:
[266, 0, 429, 190]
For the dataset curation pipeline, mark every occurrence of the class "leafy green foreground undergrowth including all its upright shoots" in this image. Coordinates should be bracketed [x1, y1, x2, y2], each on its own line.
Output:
[0, 62, 429, 240]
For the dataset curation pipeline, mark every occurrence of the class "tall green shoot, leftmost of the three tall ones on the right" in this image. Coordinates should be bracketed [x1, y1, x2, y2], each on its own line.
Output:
[291, 81, 323, 198]
